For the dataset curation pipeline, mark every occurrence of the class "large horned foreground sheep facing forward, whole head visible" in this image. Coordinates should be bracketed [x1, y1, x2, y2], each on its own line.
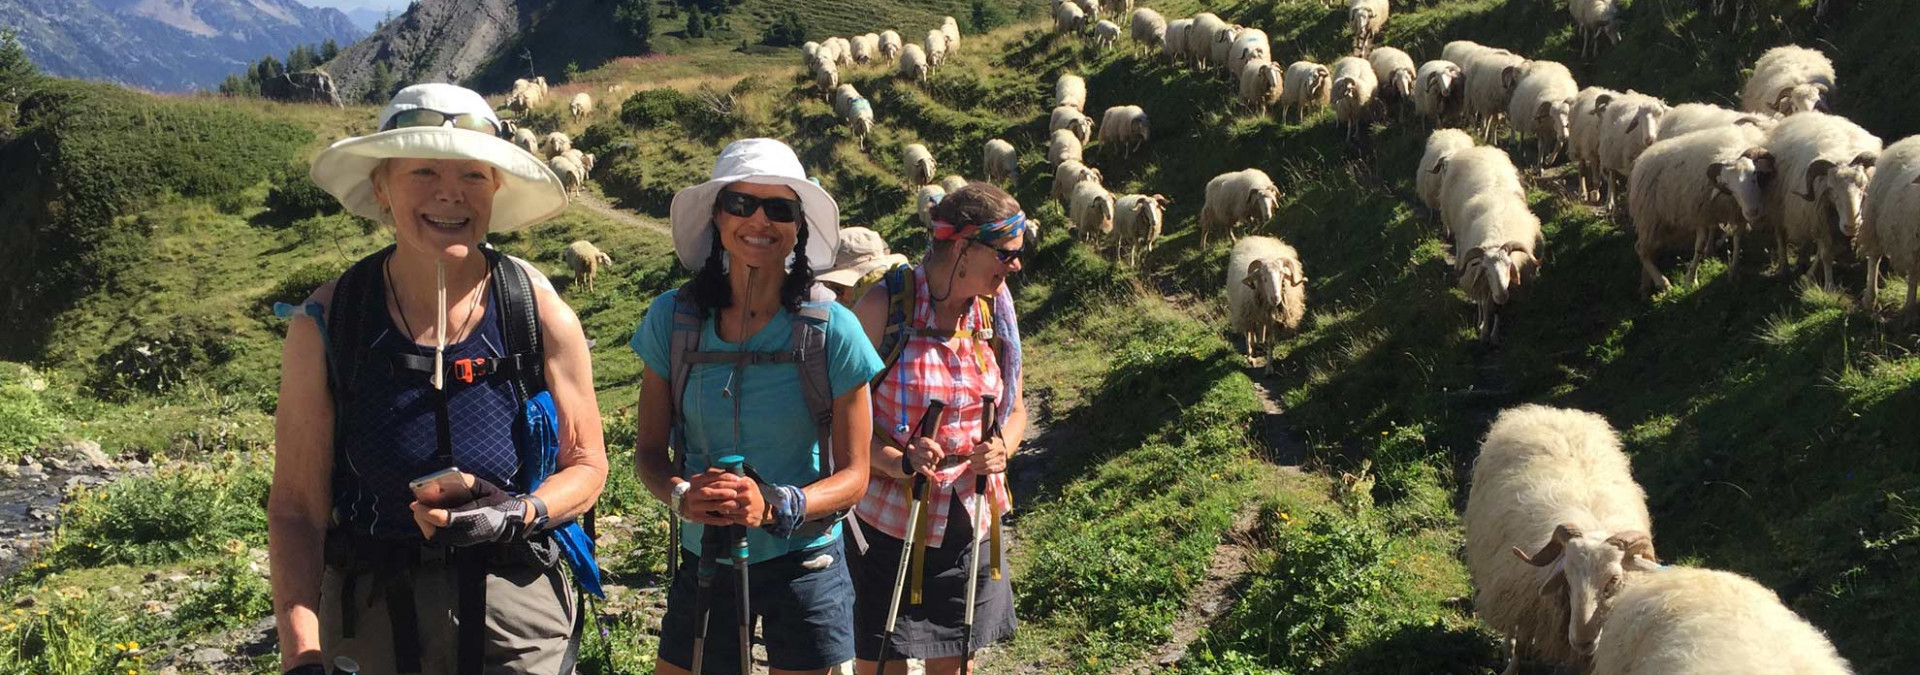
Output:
[1461, 405, 1659, 673]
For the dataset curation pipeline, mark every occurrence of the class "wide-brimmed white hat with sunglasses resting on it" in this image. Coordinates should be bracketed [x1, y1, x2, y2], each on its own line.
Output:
[311, 82, 566, 232]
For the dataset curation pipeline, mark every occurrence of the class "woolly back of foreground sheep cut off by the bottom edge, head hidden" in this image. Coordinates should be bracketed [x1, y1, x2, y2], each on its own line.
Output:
[1592, 568, 1853, 675]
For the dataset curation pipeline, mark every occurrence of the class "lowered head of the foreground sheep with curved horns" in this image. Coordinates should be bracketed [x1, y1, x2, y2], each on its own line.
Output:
[1513, 524, 1659, 654]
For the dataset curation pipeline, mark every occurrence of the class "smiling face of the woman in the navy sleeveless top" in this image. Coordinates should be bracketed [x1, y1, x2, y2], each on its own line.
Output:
[372, 157, 501, 259]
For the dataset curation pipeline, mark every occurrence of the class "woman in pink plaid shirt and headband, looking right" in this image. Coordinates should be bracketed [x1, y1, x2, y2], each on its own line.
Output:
[849, 182, 1033, 675]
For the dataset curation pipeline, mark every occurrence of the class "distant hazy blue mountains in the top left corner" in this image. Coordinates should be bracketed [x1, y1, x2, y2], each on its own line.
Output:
[0, 0, 367, 92]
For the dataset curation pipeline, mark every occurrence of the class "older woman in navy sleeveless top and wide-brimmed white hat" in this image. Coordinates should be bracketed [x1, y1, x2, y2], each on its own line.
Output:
[267, 84, 607, 675]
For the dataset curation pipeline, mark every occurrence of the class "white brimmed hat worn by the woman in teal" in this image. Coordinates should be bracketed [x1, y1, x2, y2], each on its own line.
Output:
[672, 138, 839, 272]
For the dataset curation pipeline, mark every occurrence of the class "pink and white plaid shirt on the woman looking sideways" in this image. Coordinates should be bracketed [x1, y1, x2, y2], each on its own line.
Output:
[854, 268, 1014, 547]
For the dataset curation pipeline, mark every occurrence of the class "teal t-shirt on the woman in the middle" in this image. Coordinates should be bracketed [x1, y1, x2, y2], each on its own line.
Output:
[628, 290, 881, 562]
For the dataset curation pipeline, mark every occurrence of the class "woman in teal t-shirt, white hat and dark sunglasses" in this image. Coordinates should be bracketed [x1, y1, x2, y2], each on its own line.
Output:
[632, 138, 879, 675]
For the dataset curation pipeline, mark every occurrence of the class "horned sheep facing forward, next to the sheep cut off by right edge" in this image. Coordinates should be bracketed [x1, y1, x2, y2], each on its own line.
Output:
[1766, 113, 1880, 288]
